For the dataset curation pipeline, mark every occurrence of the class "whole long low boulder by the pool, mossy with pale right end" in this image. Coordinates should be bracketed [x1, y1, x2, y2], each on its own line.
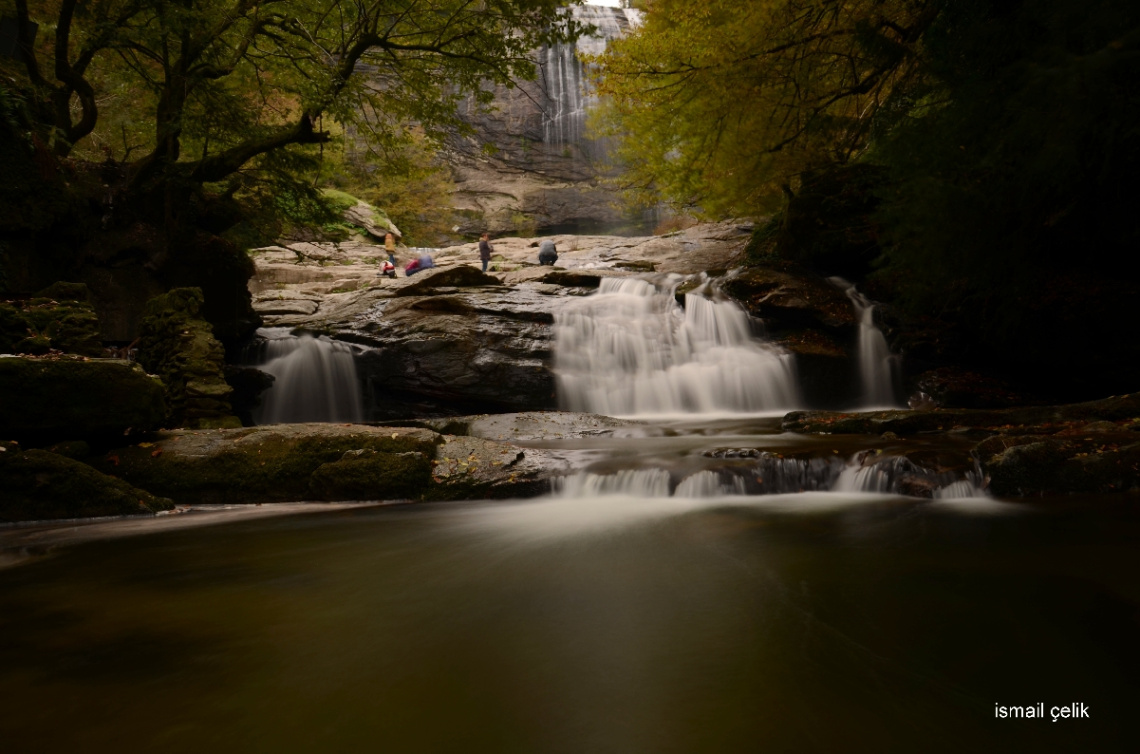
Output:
[89, 424, 567, 504]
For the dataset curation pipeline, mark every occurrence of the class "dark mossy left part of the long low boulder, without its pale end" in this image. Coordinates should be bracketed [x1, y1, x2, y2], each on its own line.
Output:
[98, 424, 439, 503]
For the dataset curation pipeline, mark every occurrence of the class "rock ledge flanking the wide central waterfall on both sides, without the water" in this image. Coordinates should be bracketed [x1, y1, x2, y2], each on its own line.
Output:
[251, 222, 889, 422]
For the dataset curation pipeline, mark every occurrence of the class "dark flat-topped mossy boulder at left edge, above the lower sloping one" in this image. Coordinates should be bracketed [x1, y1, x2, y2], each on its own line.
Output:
[0, 357, 165, 445]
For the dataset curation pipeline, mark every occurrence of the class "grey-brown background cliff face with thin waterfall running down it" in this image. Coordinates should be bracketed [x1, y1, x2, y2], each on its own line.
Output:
[451, 6, 640, 234]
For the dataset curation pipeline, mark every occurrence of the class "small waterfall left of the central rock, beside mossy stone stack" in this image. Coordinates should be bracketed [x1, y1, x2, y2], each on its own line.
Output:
[254, 327, 364, 424]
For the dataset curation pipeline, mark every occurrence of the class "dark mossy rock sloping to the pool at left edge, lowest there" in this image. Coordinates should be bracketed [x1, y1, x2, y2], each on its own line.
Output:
[0, 449, 173, 521]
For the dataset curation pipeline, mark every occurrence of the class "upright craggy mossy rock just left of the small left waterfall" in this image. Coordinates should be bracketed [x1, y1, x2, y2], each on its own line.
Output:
[138, 289, 242, 428]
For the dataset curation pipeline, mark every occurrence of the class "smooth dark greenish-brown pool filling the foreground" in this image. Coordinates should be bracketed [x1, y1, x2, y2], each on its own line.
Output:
[0, 493, 1140, 754]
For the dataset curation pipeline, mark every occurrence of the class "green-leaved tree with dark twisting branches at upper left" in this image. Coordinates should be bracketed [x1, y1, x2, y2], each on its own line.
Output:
[4, 0, 577, 218]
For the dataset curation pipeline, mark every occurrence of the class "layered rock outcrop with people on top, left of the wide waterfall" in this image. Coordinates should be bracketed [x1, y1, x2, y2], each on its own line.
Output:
[251, 222, 751, 421]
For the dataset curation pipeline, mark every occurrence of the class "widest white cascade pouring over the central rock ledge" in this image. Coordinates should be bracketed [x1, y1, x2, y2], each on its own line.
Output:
[554, 277, 799, 416]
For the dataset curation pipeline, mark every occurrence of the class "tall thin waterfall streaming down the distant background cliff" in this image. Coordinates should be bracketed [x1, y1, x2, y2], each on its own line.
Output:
[540, 5, 641, 152]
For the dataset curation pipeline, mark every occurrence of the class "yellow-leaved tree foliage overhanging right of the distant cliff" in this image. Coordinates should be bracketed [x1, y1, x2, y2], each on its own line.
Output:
[597, 0, 939, 216]
